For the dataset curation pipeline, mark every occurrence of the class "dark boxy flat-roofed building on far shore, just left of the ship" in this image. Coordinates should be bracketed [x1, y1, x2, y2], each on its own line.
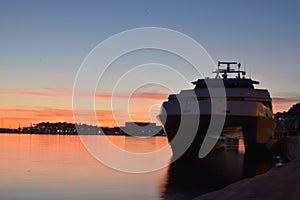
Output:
[120, 122, 165, 137]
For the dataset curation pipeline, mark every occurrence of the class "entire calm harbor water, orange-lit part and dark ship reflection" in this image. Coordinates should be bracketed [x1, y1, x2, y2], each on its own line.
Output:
[0, 134, 275, 200]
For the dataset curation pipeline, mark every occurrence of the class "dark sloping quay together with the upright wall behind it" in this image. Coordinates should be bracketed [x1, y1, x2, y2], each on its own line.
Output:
[192, 136, 300, 200]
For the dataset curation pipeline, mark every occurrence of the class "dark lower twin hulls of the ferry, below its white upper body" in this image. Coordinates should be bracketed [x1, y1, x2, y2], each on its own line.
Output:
[160, 115, 276, 158]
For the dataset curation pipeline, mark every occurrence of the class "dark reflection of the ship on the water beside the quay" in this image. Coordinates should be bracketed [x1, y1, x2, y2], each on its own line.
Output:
[161, 139, 275, 200]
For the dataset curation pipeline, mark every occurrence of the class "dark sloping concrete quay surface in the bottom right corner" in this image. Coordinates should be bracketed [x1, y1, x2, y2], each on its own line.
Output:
[196, 160, 300, 200]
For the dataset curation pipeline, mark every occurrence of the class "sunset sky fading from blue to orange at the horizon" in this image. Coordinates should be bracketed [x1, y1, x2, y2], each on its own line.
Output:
[0, 0, 300, 128]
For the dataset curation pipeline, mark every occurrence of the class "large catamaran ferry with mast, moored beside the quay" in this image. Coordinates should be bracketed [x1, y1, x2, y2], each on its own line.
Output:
[159, 62, 276, 156]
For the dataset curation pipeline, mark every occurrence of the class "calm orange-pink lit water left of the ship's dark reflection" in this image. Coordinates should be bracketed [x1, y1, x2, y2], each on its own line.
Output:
[0, 134, 167, 200]
